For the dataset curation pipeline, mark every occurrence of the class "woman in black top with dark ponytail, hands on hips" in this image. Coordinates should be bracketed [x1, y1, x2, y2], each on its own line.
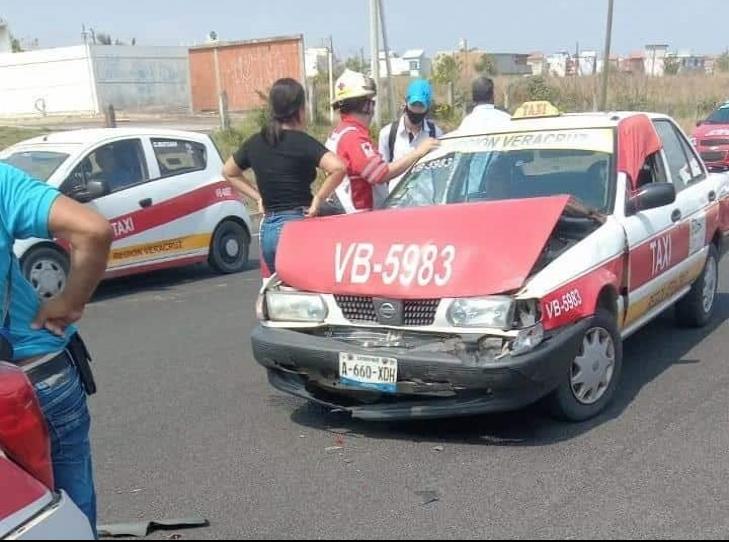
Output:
[223, 79, 346, 273]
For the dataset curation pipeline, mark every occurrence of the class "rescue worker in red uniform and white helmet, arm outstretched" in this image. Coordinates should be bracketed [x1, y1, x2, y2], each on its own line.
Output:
[327, 70, 439, 213]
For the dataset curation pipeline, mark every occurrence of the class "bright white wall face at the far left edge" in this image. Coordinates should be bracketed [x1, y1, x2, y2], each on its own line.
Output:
[0, 45, 97, 116]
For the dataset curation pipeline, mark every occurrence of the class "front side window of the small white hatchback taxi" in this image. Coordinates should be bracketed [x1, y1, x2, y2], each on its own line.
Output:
[61, 139, 149, 200]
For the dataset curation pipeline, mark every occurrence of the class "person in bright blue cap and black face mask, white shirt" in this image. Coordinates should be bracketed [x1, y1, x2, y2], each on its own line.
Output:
[379, 79, 443, 191]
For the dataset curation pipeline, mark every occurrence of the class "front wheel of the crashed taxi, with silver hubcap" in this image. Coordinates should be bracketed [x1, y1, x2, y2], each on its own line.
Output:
[547, 309, 623, 422]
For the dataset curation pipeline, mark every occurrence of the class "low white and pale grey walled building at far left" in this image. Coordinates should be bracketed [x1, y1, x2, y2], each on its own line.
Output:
[0, 45, 190, 116]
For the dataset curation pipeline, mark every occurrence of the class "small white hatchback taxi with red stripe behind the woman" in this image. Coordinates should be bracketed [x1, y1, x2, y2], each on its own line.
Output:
[0, 128, 251, 298]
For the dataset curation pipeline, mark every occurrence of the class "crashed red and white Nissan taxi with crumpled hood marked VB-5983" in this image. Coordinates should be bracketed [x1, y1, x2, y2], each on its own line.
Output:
[252, 104, 729, 421]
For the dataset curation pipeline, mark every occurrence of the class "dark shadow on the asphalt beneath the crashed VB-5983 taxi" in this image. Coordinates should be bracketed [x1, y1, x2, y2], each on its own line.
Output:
[291, 293, 729, 446]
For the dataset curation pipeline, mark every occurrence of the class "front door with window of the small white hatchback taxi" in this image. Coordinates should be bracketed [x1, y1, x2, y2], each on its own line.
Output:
[61, 138, 156, 271]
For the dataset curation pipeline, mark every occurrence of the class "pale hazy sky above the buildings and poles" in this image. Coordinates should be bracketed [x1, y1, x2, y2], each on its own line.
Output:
[0, 0, 729, 57]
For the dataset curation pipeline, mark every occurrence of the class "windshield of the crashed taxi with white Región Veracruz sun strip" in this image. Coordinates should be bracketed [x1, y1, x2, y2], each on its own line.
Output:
[386, 129, 614, 213]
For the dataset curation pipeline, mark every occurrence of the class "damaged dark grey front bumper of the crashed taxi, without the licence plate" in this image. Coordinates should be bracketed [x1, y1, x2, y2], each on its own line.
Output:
[252, 320, 589, 421]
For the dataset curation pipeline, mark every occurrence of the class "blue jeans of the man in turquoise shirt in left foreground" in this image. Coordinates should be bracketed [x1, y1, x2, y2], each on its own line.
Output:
[35, 367, 96, 532]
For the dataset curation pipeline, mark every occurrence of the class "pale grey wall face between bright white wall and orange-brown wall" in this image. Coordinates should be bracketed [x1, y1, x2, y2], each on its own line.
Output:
[91, 45, 190, 112]
